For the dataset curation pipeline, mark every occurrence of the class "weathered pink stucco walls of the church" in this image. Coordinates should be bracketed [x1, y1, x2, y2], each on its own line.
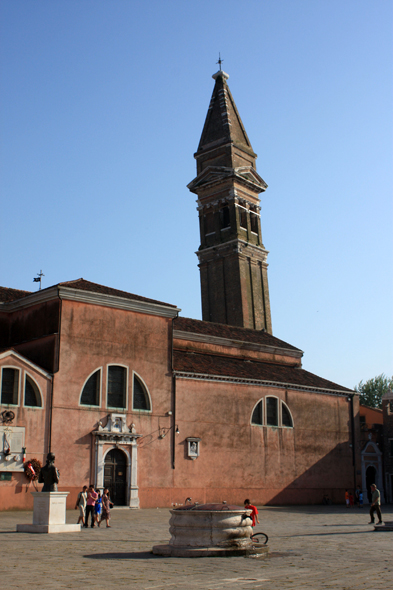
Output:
[0, 300, 358, 509]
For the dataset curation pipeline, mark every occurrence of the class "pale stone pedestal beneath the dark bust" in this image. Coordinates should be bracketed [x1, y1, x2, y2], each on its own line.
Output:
[16, 492, 81, 533]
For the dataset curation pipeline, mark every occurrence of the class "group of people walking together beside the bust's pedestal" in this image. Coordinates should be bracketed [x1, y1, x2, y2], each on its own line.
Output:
[75, 485, 113, 528]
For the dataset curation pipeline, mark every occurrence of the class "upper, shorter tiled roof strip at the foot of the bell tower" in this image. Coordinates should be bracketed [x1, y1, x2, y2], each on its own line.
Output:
[174, 317, 301, 352]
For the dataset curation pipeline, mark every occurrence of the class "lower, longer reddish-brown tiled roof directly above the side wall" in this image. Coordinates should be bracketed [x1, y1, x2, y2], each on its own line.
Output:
[174, 350, 352, 392]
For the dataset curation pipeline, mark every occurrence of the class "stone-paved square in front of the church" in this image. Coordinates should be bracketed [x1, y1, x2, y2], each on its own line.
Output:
[0, 506, 393, 590]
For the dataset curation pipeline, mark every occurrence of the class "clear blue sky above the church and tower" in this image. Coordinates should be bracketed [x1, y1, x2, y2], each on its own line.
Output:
[0, 0, 393, 387]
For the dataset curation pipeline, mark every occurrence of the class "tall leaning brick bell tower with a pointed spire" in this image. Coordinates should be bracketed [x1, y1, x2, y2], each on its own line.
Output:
[188, 69, 272, 334]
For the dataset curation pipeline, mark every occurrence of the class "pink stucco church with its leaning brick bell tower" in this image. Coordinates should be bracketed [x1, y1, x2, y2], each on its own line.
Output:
[0, 70, 360, 509]
